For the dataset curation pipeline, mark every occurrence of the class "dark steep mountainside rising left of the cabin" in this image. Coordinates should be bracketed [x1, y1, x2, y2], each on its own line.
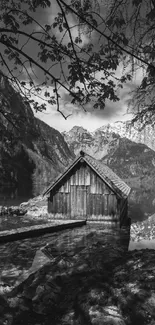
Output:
[0, 75, 74, 196]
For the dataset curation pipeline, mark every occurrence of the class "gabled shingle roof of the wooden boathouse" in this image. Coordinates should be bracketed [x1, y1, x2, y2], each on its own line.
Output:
[43, 151, 131, 198]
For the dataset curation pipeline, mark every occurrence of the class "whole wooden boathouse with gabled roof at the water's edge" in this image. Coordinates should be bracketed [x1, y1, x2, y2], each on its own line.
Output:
[44, 151, 130, 227]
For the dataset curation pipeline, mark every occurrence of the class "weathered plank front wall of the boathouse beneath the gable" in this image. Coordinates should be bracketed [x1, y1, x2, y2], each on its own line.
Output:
[48, 163, 118, 220]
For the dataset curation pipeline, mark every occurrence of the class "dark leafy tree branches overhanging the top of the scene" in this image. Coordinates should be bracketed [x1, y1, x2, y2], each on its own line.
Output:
[0, 0, 155, 124]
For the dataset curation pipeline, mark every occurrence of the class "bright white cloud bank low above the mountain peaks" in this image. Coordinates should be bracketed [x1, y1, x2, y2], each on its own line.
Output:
[34, 83, 133, 132]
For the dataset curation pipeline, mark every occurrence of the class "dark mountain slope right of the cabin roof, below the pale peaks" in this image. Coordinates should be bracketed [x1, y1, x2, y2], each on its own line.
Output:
[102, 138, 155, 221]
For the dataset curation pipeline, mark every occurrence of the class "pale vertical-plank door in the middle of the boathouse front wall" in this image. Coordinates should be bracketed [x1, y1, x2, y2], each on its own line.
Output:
[70, 185, 88, 219]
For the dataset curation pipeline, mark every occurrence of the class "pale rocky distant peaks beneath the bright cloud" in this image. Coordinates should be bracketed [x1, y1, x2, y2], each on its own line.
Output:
[63, 121, 155, 159]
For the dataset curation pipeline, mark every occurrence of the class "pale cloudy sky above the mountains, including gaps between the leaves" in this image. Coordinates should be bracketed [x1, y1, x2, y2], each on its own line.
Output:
[0, 0, 142, 132]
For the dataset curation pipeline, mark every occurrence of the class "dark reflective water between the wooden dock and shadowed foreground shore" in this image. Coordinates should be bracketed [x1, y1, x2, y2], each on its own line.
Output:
[0, 223, 130, 285]
